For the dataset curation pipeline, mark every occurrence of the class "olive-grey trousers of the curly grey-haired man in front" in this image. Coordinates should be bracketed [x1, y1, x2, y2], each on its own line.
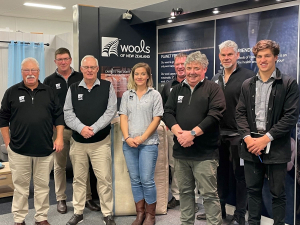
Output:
[175, 159, 222, 225]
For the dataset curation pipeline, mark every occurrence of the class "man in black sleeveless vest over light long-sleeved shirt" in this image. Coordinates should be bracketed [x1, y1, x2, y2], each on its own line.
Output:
[64, 55, 117, 225]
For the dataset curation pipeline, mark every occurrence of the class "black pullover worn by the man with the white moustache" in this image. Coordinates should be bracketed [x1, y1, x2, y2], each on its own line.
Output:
[0, 82, 64, 157]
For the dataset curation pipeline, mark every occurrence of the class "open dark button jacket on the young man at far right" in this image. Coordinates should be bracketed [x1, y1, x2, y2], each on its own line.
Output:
[236, 69, 299, 164]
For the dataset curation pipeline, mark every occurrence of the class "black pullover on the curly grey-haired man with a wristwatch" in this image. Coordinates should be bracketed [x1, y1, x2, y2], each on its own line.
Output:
[163, 79, 226, 161]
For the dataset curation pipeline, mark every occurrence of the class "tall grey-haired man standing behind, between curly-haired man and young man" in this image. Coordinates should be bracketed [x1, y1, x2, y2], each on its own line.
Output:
[197, 40, 255, 225]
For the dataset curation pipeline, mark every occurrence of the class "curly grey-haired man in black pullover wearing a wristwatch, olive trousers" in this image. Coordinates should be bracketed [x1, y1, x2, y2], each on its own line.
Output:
[163, 51, 225, 225]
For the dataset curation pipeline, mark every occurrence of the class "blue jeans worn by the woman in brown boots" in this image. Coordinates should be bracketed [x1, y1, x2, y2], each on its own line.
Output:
[123, 142, 158, 204]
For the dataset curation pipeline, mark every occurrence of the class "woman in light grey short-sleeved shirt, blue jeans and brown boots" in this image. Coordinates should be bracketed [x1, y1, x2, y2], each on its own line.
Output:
[120, 63, 163, 225]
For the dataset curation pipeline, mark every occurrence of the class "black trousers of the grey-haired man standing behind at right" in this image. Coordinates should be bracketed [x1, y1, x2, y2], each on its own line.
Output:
[218, 136, 247, 217]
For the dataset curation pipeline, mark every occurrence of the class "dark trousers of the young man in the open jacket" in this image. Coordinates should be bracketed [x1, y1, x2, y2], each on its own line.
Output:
[245, 161, 287, 225]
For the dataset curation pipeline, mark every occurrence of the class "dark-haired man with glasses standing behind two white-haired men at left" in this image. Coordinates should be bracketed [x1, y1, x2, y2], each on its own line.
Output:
[44, 48, 100, 214]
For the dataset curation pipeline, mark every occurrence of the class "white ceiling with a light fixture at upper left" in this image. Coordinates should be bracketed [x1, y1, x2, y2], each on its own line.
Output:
[0, 0, 166, 22]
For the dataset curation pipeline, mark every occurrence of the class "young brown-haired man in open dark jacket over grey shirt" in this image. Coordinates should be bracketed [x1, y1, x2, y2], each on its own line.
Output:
[236, 40, 299, 225]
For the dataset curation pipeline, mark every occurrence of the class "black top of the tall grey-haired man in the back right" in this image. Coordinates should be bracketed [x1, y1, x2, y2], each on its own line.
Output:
[212, 65, 255, 134]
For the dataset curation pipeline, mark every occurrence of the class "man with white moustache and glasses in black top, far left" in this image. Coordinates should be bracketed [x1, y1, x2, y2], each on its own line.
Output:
[0, 58, 64, 225]
